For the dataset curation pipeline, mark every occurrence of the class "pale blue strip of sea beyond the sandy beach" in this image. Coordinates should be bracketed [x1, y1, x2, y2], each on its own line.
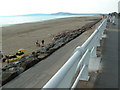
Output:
[0, 15, 91, 27]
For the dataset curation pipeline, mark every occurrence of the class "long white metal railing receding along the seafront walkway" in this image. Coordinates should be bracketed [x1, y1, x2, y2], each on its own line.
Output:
[43, 18, 107, 89]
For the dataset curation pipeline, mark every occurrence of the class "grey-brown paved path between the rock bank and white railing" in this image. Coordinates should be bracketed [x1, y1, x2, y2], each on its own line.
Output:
[3, 20, 99, 88]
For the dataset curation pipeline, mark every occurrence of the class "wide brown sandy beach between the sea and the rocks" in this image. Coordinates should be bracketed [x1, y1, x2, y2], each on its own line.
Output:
[2, 16, 101, 54]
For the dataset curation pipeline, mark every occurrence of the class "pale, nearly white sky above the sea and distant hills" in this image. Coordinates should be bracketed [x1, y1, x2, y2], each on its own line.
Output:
[0, 0, 120, 16]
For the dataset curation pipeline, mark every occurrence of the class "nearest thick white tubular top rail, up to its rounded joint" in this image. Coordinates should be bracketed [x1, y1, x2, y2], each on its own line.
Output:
[43, 48, 80, 88]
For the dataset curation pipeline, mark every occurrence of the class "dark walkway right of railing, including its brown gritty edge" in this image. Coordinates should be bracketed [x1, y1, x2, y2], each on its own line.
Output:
[77, 18, 120, 89]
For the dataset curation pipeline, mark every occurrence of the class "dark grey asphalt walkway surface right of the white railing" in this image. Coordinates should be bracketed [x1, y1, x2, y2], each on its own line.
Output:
[94, 18, 120, 88]
